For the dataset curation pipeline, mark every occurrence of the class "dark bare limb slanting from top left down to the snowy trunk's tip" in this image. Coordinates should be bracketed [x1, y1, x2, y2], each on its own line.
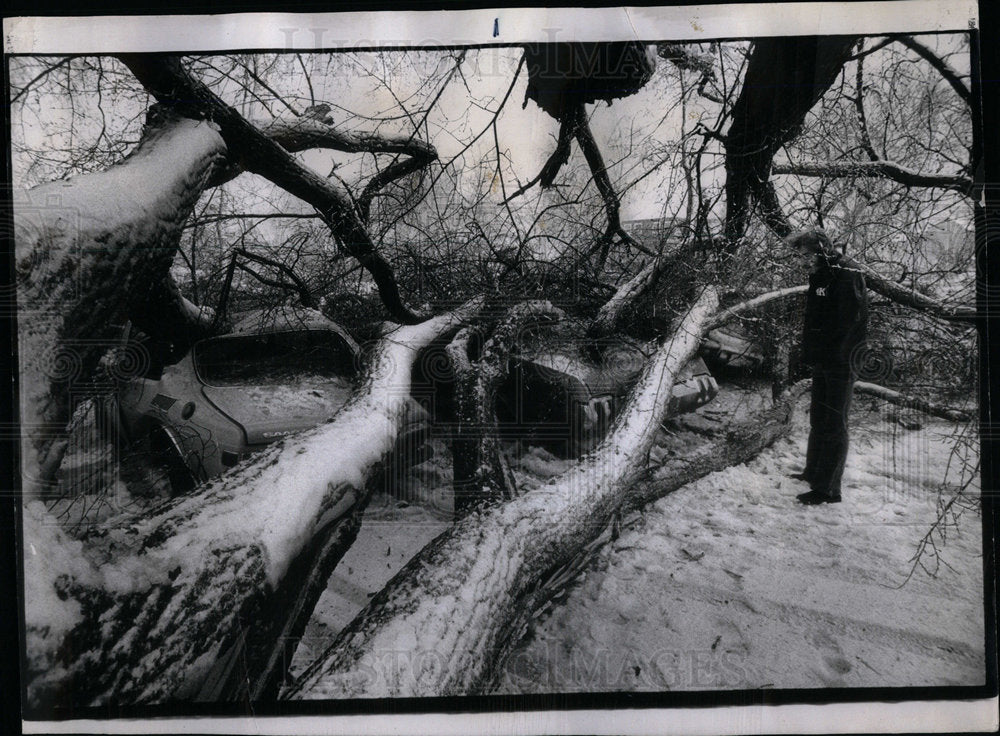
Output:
[119, 54, 421, 324]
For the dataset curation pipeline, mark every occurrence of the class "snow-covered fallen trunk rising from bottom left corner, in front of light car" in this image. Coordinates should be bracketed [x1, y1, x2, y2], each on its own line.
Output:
[24, 303, 478, 708]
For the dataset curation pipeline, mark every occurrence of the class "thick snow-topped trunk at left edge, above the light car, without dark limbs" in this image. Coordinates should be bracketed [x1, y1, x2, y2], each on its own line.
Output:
[14, 110, 226, 496]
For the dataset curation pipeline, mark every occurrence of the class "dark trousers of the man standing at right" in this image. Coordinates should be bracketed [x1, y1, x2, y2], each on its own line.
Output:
[804, 365, 854, 498]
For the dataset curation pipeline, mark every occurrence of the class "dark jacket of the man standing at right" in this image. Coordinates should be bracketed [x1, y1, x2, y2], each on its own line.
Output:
[802, 256, 868, 368]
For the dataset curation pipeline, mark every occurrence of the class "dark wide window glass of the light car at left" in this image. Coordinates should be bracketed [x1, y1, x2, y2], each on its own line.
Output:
[194, 330, 353, 386]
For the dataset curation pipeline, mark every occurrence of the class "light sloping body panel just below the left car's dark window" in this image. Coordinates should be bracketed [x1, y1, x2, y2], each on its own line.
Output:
[202, 376, 353, 445]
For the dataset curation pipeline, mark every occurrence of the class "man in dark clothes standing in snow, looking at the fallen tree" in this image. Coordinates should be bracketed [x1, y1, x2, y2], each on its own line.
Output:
[787, 228, 868, 505]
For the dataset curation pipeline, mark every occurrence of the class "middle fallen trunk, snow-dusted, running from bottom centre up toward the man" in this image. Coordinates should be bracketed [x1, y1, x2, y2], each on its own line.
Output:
[287, 289, 718, 698]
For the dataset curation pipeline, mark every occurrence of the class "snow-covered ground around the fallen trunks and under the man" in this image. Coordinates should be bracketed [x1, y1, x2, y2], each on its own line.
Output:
[291, 388, 984, 692]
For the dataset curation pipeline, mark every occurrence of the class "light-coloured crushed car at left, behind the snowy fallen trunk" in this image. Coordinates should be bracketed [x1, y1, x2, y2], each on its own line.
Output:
[103, 308, 428, 493]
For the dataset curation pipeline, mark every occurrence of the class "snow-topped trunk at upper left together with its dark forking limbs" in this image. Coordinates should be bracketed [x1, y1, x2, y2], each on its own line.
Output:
[14, 63, 437, 496]
